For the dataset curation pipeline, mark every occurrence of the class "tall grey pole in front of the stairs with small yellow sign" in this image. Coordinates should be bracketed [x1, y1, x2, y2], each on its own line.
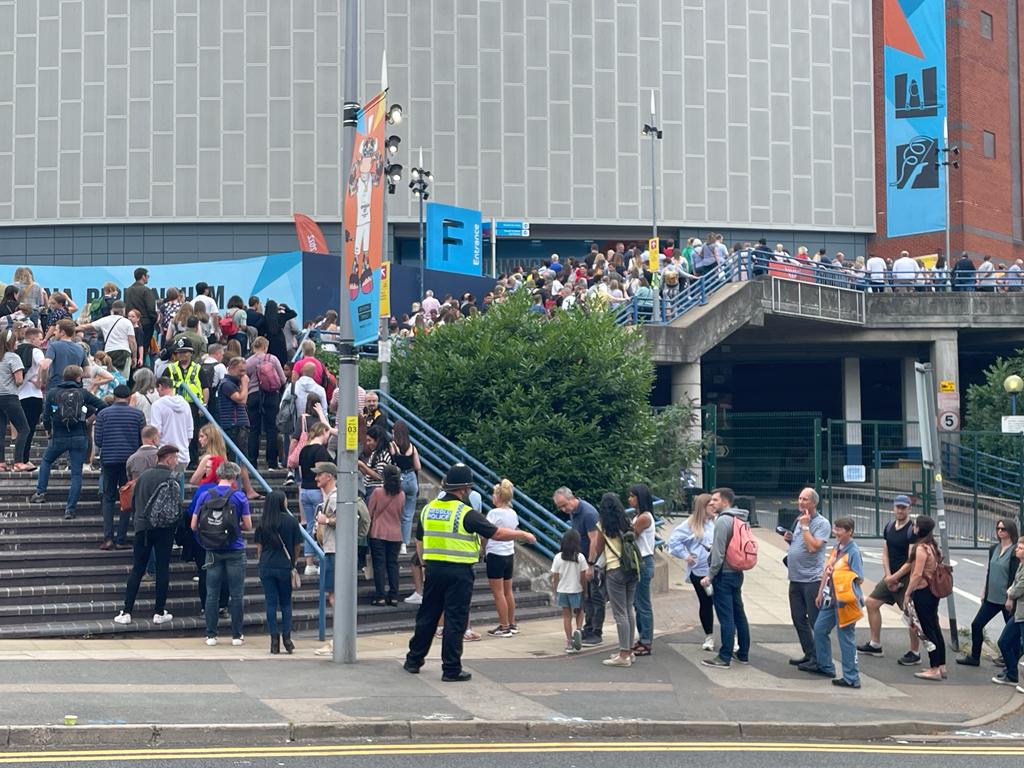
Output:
[333, 0, 359, 664]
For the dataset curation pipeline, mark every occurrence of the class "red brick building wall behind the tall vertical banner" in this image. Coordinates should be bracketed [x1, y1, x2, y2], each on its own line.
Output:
[867, 0, 1024, 263]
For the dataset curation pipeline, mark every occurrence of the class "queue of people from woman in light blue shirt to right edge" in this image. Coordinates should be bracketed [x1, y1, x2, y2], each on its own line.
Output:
[663, 487, 1024, 693]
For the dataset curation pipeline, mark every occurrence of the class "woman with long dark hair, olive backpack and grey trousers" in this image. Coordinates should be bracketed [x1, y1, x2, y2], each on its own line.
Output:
[590, 494, 637, 667]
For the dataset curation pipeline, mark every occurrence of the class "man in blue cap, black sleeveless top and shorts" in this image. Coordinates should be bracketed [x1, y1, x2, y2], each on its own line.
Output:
[857, 495, 921, 667]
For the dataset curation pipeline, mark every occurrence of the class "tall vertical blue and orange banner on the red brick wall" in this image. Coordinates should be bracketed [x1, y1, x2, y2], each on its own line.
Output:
[883, 0, 947, 238]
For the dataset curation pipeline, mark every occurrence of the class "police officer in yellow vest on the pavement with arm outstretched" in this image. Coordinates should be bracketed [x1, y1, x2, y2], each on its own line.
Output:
[404, 464, 537, 683]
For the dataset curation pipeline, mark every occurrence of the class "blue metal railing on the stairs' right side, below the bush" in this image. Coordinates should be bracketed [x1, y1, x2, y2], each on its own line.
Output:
[379, 392, 569, 557]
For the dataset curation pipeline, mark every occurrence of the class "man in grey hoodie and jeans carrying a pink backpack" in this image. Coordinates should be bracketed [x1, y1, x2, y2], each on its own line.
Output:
[700, 488, 751, 669]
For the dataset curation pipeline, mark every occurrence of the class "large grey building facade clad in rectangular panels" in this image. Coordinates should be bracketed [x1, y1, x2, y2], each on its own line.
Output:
[0, 0, 874, 263]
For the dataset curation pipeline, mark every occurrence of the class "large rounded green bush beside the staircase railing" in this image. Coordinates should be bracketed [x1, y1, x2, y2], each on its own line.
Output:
[390, 292, 679, 504]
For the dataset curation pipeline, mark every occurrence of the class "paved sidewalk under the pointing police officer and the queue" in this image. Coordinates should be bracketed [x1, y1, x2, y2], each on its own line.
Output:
[0, 530, 1024, 750]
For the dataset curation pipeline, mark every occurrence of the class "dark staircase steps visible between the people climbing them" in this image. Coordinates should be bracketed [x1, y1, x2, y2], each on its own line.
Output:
[0, 437, 553, 639]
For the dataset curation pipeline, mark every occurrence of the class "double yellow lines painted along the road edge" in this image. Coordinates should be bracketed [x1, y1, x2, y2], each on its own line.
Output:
[0, 741, 1024, 765]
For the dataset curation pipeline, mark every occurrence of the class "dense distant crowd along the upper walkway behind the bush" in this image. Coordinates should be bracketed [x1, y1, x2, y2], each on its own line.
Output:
[378, 232, 1024, 338]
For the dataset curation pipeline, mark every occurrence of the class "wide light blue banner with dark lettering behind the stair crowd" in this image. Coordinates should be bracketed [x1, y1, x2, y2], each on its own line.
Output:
[9, 251, 303, 317]
